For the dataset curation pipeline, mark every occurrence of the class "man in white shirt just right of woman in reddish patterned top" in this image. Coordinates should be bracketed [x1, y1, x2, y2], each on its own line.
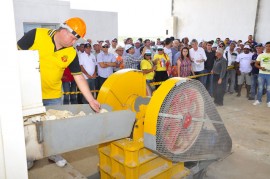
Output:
[189, 39, 207, 86]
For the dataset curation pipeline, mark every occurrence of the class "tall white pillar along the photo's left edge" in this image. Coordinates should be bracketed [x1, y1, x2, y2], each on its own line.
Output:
[0, 1, 28, 179]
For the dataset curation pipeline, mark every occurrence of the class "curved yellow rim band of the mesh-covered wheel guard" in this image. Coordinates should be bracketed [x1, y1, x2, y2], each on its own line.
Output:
[144, 77, 187, 136]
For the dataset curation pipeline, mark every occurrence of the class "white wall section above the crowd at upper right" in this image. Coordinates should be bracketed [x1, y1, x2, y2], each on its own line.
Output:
[173, 0, 258, 41]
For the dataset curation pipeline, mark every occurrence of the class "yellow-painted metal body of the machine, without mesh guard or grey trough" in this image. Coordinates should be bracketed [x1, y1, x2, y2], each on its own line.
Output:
[98, 70, 189, 179]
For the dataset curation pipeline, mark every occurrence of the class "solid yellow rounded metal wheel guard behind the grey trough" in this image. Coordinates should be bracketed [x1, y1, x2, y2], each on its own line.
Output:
[97, 69, 146, 112]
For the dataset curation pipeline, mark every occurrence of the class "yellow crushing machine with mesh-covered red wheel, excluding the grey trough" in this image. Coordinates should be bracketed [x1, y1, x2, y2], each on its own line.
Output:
[98, 70, 232, 179]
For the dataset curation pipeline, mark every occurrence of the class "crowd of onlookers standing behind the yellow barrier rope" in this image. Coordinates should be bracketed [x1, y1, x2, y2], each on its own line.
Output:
[63, 35, 270, 107]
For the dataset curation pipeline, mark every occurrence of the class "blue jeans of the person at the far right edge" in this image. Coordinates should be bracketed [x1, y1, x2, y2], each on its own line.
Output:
[257, 74, 270, 103]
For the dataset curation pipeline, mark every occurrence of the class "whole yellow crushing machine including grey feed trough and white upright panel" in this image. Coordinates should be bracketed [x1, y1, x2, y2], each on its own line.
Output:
[20, 51, 232, 179]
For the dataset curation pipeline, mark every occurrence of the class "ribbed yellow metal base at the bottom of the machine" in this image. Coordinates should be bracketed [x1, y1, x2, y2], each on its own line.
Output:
[99, 139, 188, 179]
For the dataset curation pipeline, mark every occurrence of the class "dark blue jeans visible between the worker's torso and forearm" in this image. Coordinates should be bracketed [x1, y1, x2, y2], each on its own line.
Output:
[62, 81, 77, 104]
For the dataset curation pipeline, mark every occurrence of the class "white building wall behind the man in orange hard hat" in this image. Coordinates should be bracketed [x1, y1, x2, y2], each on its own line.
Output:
[13, 0, 118, 43]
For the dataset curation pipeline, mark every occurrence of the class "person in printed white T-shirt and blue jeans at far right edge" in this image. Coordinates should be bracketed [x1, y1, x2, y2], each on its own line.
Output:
[253, 41, 270, 107]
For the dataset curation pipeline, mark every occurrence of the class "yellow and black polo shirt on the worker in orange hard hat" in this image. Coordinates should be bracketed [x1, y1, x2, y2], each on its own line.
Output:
[17, 28, 81, 99]
